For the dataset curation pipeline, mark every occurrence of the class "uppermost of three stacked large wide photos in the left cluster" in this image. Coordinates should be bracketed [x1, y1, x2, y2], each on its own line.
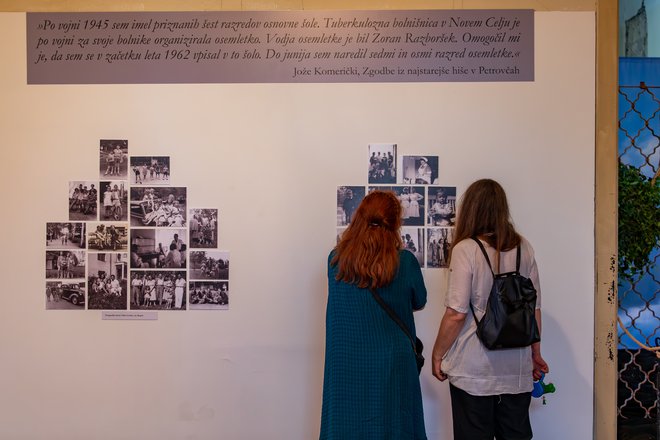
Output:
[131, 186, 186, 227]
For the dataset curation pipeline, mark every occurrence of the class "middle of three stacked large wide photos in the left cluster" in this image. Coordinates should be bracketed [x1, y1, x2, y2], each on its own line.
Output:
[130, 228, 188, 269]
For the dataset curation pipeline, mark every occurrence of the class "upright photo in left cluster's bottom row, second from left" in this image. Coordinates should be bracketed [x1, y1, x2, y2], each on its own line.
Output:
[87, 252, 128, 310]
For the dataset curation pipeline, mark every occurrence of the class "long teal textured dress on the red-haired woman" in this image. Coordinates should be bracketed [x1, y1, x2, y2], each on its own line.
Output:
[320, 251, 428, 440]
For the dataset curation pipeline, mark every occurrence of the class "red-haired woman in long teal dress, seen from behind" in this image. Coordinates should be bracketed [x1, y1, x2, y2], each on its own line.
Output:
[320, 191, 426, 440]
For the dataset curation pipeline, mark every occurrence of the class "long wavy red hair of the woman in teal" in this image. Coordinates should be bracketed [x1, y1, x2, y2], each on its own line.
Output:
[330, 191, 403, 288]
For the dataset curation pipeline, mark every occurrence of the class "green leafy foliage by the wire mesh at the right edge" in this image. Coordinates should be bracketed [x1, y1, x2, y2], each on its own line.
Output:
[619, 162, 660, 281]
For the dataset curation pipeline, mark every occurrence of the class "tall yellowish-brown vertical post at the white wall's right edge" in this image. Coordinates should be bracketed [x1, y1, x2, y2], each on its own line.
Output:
[594, 0, 619, 440]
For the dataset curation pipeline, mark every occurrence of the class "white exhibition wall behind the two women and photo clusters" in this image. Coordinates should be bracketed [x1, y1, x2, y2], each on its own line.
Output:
[0, 12, 595, 440]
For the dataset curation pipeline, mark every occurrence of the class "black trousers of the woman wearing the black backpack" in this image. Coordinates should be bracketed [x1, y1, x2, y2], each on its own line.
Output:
[449, 384, 532, 440]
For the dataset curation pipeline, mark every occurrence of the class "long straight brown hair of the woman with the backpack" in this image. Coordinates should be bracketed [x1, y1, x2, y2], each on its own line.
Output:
[452, 179, 521, 269]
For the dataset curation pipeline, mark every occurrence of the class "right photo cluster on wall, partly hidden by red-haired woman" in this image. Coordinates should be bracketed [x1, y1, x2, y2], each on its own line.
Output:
[336, 143, 456, 269]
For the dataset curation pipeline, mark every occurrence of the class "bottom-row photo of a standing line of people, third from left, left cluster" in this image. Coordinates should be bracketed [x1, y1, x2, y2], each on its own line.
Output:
[129, 270, 187, 310]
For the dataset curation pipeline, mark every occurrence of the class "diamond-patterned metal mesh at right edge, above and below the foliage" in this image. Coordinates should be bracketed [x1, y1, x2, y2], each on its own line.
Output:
[618, 83, 660, 426]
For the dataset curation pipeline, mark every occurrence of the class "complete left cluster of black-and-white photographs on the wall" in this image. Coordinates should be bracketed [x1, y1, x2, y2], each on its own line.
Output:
[45, 139, 229, 310]
